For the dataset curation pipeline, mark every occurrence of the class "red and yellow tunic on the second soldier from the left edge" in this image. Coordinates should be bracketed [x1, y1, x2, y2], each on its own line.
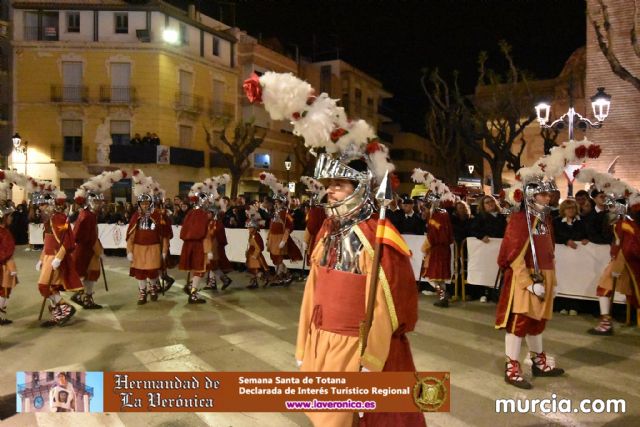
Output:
[38, 212, 82, 297]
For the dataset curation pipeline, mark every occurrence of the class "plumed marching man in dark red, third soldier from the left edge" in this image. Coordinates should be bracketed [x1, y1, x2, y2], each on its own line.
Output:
[71, 171, 126, 310]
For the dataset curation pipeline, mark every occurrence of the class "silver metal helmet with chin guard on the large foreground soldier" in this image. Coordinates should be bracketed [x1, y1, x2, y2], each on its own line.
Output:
[313, 153, 373, 219]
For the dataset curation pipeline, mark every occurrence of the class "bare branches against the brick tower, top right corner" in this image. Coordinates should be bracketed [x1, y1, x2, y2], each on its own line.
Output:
[587, 0, 640, 91]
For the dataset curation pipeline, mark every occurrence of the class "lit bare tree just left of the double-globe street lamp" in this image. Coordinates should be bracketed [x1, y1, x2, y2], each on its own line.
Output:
[470, 41, 536, 192]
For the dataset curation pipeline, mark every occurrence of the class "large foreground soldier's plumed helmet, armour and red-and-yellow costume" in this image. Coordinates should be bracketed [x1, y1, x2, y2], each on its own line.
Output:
[245, 72, 425, 426]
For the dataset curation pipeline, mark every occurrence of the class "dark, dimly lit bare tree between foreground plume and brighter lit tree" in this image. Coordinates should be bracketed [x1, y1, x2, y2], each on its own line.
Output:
[420, 68, 469, 183]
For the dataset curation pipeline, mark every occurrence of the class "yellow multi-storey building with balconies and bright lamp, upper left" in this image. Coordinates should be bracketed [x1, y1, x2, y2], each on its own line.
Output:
[10, 0, 239, 198]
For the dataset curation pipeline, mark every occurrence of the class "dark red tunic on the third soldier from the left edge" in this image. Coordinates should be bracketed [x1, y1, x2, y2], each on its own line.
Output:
[73, 209, 103, 281]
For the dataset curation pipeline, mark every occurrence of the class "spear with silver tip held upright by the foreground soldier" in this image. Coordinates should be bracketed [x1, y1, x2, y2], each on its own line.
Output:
[360, 170, 393, 362]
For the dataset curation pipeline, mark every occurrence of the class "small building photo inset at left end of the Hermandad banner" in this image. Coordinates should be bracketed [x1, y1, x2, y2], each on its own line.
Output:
[16, 371, 103, 412]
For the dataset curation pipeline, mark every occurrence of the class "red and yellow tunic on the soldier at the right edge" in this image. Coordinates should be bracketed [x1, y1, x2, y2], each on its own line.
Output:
[596, 218, 640, 308]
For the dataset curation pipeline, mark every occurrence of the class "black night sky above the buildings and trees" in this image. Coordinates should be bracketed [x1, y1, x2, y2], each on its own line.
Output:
[171, 0, 586, 133]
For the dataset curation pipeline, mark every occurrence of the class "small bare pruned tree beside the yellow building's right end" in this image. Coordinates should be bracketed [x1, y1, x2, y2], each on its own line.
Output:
[204, 121, 267, 197]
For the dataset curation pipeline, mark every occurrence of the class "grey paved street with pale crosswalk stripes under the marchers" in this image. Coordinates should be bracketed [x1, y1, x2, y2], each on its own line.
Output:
[0, 247, 640, 427]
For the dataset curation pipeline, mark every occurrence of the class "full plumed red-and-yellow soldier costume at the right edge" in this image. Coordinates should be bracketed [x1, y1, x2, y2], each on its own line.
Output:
[576, 168, 640, 335]
